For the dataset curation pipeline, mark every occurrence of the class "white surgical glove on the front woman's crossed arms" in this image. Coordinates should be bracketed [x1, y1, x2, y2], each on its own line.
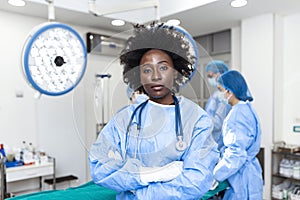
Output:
[140, 161, 183, 185]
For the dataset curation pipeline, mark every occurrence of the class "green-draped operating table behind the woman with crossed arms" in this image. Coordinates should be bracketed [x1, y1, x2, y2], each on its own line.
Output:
[9, 181, 228, 200]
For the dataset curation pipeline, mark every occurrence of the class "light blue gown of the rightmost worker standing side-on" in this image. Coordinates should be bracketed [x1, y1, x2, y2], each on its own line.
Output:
[214, 101, 263, 200]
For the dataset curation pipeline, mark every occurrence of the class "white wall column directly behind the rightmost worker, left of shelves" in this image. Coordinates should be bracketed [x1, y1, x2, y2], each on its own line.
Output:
[241, 14, 274, 199]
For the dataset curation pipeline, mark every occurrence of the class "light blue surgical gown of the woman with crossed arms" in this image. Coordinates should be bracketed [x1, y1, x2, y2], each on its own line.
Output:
[89, 97, 219, 200]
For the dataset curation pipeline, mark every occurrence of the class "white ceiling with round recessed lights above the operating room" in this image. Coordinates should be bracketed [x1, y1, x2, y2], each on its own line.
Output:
[0, 0, 300, 36]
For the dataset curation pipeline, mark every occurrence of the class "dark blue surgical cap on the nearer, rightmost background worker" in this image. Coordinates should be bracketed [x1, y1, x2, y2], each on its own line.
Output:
[217, 70, 253, 101]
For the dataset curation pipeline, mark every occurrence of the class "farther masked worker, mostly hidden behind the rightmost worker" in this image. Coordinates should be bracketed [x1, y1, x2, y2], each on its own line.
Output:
[205, 60, 231, 149]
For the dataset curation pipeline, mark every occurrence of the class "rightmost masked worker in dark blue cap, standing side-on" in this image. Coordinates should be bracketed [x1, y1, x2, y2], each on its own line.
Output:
[213, 70, 263, 200]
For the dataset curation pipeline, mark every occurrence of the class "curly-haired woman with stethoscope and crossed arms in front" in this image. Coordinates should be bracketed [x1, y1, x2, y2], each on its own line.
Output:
[89, 24, 219, 200]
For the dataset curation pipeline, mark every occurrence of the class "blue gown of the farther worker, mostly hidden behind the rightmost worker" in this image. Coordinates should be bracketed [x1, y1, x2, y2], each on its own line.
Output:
[205, 91, 231, 149]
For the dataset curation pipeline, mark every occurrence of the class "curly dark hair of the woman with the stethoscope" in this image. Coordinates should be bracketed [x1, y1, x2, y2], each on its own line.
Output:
[120, 23, 197, 92]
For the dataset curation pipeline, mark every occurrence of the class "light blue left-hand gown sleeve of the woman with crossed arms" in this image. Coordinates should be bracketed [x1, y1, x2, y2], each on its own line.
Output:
[89, 112, 145, 192]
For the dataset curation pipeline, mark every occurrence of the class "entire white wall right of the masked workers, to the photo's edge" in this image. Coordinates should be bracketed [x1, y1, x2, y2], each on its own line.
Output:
[241, 13, 300, 199]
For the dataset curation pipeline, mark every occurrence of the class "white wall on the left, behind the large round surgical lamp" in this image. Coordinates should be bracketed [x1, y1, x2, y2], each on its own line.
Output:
[0, 11, 128, 191]
